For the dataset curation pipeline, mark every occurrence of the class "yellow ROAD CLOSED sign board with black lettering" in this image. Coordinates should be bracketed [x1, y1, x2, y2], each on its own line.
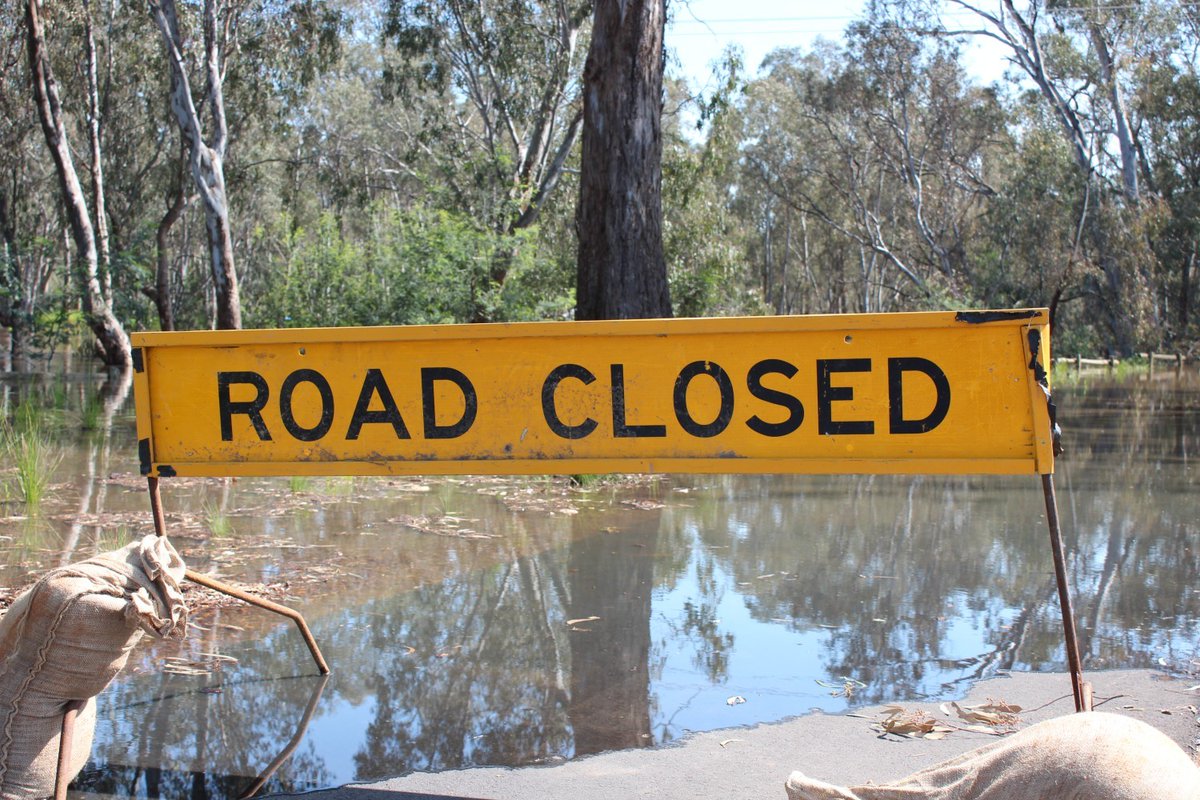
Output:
[133, 309, 1054, 477]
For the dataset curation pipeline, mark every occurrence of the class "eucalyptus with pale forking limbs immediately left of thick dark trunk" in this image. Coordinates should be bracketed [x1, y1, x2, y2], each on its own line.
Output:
[382, 0, 592, 320]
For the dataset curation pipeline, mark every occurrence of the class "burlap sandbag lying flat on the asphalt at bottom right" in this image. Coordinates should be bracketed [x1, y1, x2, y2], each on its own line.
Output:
[786, 712, 1200, 800]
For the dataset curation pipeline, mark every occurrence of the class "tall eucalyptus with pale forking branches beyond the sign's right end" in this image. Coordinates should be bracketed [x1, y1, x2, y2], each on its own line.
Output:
[938, 0, 1192, 353]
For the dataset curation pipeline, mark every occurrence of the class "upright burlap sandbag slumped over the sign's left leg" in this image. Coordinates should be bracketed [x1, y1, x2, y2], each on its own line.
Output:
[0, 535, 187, 800]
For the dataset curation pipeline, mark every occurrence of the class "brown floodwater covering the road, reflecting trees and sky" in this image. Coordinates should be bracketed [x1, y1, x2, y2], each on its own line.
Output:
[0, 373, 1200, 799]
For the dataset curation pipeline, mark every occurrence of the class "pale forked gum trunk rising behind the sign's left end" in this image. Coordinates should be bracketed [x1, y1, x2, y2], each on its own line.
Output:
[150, 0, 241, 330]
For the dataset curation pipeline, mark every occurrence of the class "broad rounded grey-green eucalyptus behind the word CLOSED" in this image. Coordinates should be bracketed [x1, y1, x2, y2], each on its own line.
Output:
[743, 17, 1004, 312]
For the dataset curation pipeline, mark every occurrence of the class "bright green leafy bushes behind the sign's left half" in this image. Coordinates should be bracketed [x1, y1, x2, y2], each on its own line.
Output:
[246, 209, 566, 327]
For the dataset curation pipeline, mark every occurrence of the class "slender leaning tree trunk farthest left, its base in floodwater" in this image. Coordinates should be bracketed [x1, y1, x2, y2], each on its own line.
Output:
[25, 0, 131, 367]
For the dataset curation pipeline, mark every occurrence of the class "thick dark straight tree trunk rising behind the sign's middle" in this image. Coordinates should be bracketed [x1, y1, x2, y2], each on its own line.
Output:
[575, 0, 671, 319]
